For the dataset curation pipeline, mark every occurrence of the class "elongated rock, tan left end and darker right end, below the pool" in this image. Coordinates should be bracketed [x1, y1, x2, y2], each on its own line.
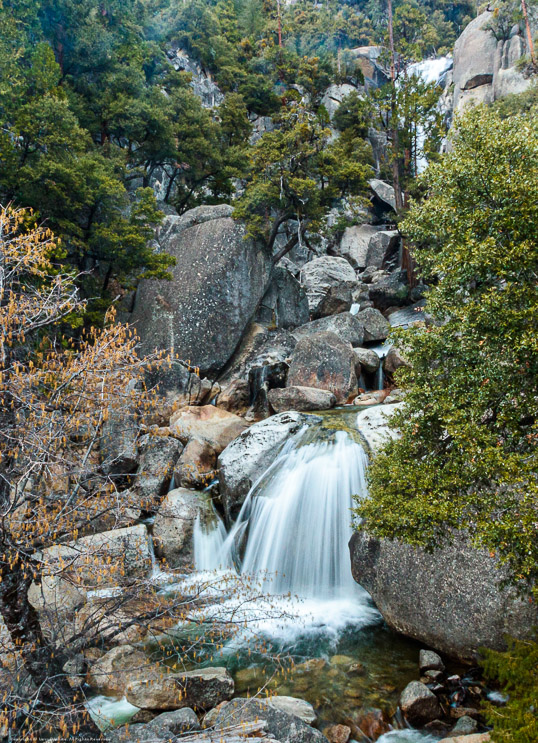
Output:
[125, 667, 234, 710]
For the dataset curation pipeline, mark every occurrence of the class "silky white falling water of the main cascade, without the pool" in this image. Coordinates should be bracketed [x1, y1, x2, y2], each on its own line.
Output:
[196, 427, 367, 599]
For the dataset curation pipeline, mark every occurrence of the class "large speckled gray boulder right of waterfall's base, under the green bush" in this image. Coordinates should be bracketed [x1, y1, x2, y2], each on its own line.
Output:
[350, 530, 538, 660]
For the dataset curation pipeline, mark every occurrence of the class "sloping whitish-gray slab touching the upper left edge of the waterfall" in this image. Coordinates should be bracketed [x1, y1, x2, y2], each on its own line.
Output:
[218, 412, 310, 518]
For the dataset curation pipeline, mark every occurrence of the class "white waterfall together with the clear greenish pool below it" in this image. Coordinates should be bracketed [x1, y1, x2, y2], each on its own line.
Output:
[93, 408, 436, 743]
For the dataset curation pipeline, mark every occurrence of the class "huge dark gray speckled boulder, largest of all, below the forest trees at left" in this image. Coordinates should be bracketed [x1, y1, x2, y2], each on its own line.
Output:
[132, 205, 272, 378]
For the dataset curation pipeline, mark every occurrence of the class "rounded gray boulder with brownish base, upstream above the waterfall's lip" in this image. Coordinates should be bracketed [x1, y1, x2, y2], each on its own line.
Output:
[286, 332, 358, 403]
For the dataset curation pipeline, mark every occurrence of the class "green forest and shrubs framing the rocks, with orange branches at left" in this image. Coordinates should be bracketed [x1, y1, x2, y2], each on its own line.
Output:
[0, 0, 538, 743]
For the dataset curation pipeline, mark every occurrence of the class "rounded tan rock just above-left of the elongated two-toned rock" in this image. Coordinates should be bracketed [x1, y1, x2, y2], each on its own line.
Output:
[86, 645, 150, 697]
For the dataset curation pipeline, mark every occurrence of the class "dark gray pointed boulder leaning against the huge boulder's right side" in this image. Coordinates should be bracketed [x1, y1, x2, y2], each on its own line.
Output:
[258, 266, 309, 329]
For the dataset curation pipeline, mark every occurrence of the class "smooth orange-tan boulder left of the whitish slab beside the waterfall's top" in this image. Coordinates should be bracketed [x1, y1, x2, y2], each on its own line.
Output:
[170, 405, 248, 454]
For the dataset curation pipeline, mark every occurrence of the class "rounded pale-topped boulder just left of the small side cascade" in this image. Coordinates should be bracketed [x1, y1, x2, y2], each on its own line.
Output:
[153, 488, 208, 568]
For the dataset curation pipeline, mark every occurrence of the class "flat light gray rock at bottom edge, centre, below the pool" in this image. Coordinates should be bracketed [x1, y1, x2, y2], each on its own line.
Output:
[211, 698, 327, 743]
